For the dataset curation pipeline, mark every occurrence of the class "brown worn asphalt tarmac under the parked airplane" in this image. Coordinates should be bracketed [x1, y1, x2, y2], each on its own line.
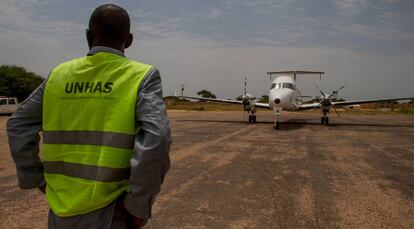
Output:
[0, 111, 414, 228]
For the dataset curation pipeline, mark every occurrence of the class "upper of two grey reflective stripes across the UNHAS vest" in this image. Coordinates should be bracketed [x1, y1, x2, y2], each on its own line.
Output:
[43, 131, 135, 149]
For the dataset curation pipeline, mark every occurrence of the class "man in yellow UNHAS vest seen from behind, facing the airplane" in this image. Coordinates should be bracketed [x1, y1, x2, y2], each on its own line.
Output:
[7, 4, 171, 228]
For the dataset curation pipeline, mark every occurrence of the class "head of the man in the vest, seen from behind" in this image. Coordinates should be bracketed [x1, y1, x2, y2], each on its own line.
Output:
[86, 4, 132, 52]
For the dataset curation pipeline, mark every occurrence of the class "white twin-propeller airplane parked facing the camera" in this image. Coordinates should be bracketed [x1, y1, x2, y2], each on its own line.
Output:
[183, 71, 413, 130]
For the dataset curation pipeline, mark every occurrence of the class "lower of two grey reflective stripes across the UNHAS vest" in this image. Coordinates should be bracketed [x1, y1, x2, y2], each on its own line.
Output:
[43, 161, 131, 182]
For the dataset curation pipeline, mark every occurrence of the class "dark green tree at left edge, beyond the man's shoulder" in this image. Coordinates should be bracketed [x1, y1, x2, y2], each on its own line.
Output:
[0, 65, 44, 101]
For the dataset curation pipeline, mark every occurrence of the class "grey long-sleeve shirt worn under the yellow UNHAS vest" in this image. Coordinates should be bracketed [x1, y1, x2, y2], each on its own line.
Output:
[7, 47, 171, 228]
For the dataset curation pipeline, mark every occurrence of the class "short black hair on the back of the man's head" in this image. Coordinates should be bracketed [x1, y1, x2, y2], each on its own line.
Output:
[89, 4, 131, 42]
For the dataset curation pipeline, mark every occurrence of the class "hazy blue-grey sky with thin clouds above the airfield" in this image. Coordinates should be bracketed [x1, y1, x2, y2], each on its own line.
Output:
[0, 0, 414, 99]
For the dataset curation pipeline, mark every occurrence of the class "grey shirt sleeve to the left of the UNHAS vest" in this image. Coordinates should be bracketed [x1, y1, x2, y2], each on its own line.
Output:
[7, 80, 46, 189]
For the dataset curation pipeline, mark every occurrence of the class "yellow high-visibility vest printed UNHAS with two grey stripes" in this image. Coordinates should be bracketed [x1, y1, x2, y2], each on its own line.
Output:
[43, 52, 151, 217]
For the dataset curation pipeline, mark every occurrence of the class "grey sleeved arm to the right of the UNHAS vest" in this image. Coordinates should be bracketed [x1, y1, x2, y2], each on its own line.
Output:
[124, 68, 171, 219]
